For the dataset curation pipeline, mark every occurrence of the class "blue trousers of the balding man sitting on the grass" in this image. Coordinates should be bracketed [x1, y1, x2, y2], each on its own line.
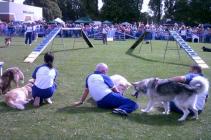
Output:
[97, 92, 138, 113]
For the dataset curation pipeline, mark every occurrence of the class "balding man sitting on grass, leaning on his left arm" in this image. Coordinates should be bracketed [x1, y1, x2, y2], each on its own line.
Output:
[74, 63, 138, 116]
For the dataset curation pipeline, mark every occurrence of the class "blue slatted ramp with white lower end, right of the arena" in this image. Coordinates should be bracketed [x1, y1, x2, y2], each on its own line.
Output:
[169, 31, 209, 69]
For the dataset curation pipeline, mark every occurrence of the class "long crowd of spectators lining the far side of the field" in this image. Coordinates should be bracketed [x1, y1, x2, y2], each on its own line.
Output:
[0, 22, 211, 43]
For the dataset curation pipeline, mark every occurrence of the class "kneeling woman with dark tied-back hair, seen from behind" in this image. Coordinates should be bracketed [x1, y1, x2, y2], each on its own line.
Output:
[32, 52, 57, 107]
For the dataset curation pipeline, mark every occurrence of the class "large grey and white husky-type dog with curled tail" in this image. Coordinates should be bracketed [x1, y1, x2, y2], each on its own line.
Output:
[132, 76, 209, 121]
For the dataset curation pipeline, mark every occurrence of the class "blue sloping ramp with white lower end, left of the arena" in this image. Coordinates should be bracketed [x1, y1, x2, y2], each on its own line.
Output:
[24, 28, 61, 63]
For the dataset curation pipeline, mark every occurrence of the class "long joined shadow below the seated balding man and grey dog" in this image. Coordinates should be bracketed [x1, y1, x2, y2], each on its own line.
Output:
[57, 106, 184, 126]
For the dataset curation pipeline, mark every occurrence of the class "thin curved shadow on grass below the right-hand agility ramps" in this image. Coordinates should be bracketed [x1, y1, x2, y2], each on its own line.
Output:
[125, 49, 189, 67]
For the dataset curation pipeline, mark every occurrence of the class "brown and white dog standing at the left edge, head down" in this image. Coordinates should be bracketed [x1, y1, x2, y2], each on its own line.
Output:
[0, 67, 24, 94]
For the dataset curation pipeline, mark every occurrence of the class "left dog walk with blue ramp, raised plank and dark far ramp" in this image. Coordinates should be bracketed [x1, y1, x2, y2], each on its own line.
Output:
[24, 27, 94, 63]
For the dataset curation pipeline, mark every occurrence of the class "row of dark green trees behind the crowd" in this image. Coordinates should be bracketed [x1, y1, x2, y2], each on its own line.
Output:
[24, 0, 211, 24]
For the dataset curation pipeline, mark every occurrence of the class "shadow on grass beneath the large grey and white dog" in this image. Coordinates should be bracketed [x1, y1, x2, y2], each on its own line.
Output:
[128, 113, 184, 126]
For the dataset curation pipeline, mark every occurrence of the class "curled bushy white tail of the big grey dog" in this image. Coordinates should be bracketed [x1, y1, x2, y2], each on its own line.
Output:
[190, 76, 209, 94]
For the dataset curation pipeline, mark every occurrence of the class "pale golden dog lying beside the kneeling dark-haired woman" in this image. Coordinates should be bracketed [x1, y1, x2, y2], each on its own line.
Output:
[4, 82, 33, 110]
